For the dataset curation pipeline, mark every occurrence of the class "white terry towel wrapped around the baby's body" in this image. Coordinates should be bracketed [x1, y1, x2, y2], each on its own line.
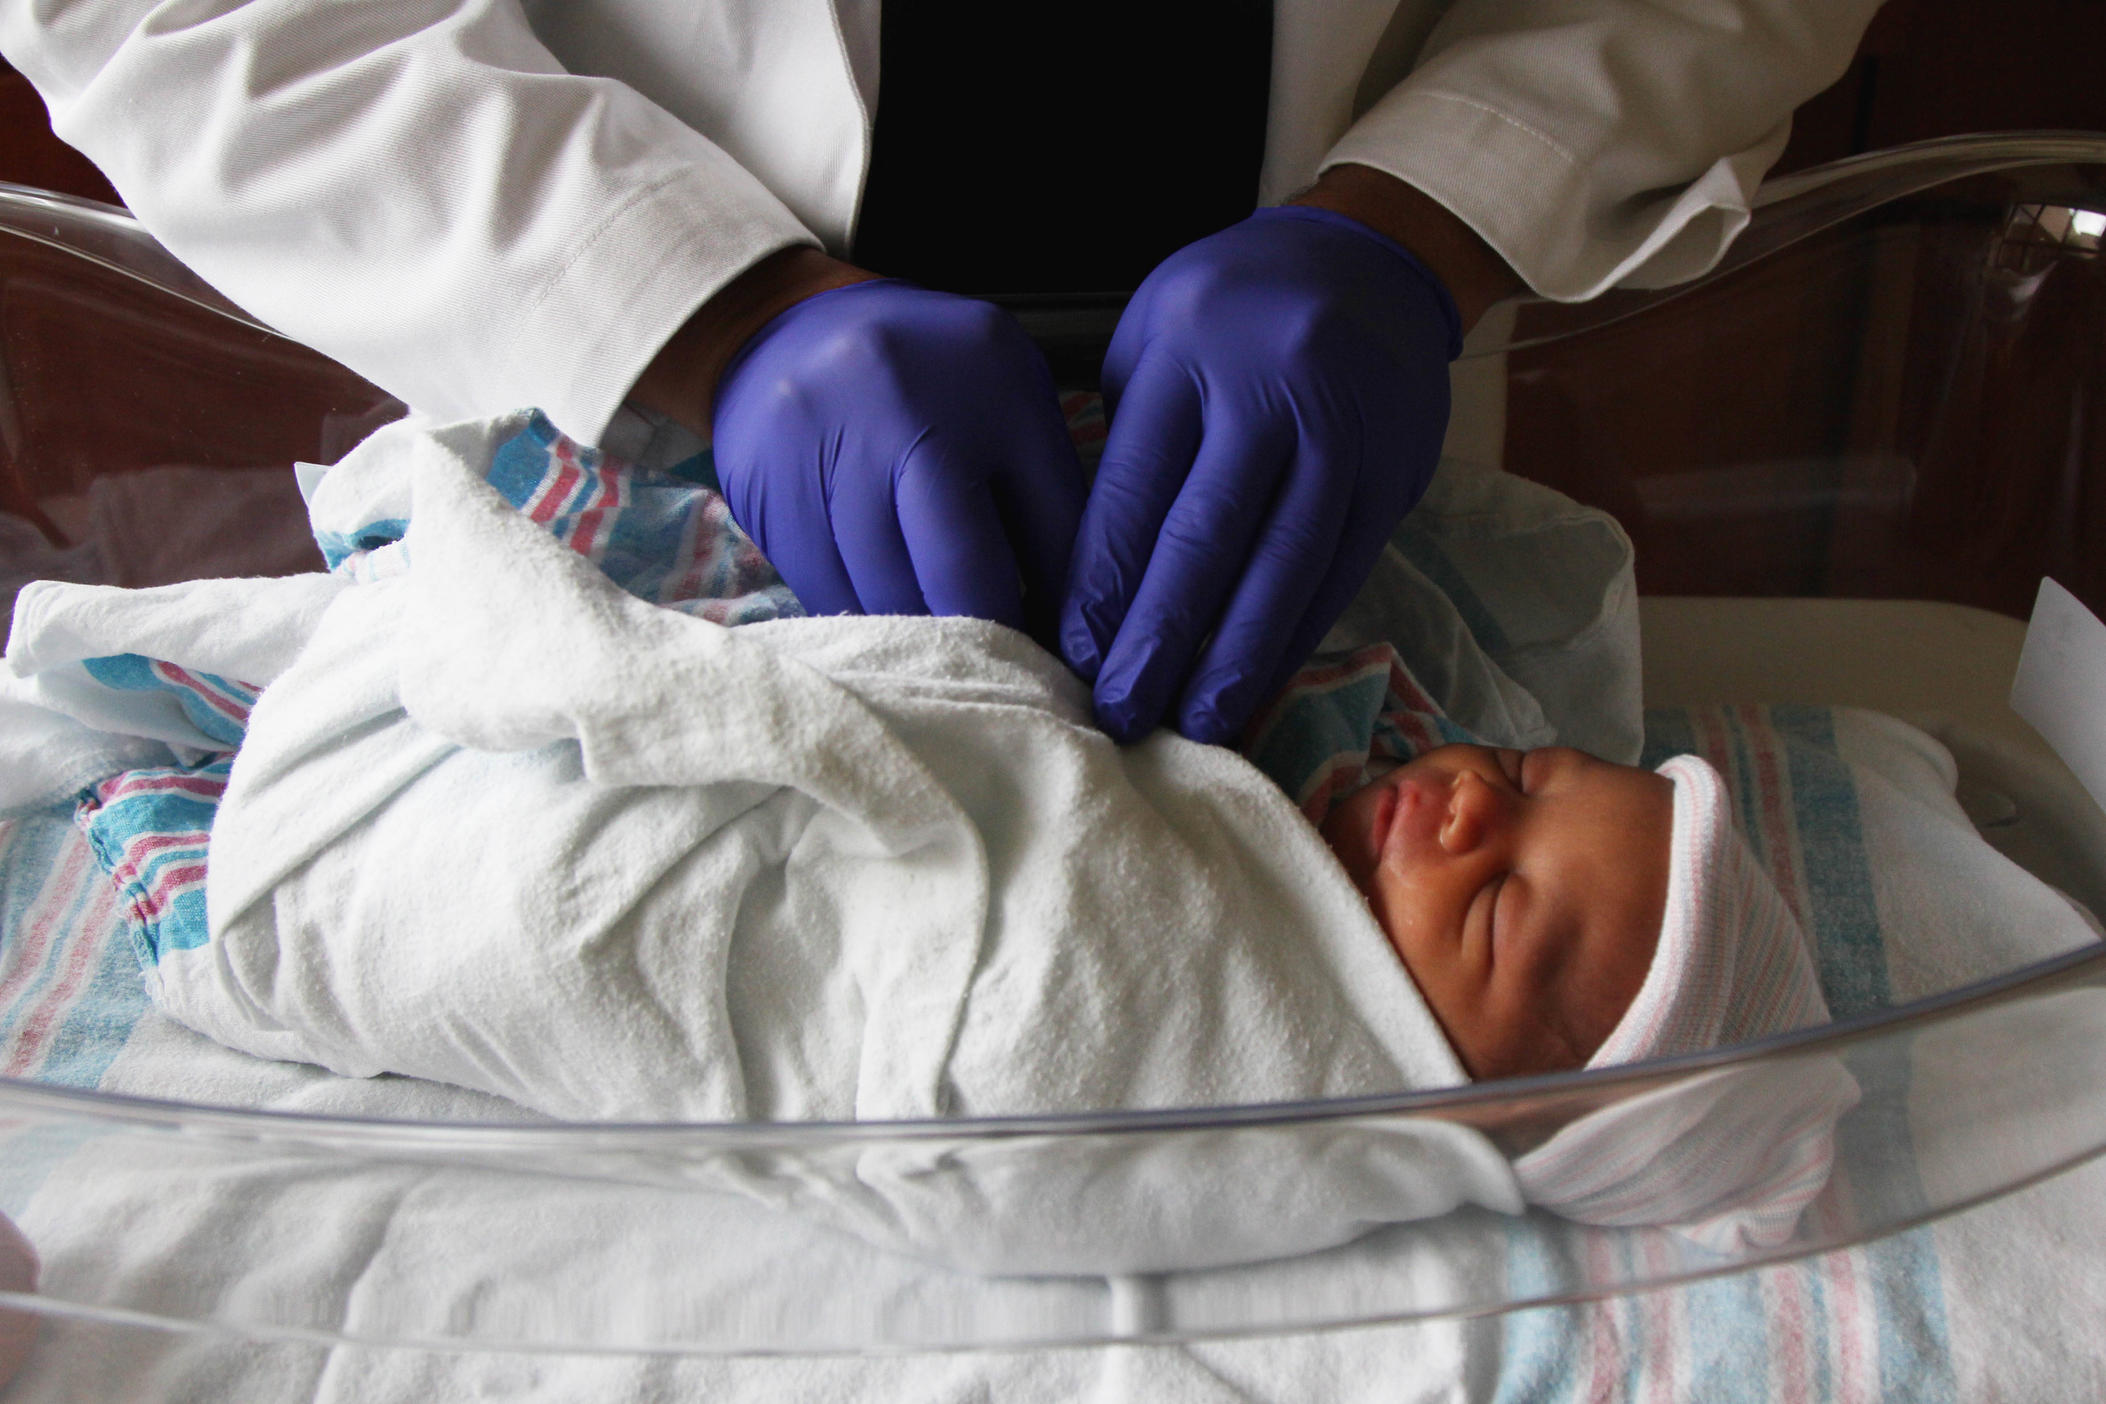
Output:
[164, 429, 1518, 1271]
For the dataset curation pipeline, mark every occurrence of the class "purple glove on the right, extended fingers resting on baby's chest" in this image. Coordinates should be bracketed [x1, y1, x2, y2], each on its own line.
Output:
[1059, 206, 1462, 741]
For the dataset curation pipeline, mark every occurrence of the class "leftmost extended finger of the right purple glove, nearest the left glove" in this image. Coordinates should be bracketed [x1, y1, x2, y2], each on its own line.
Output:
[1059, 358, 1203, 680]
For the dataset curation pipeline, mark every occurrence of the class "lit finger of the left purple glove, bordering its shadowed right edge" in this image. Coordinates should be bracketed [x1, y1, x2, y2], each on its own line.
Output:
[897, 438, 1024, 629]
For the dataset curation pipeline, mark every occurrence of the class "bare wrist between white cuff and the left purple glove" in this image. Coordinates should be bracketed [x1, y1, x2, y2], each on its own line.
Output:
[630, 246, 876, 438]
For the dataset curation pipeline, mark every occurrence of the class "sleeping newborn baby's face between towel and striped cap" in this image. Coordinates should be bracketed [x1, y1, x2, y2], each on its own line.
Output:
[1323, 745, 1674, 1080]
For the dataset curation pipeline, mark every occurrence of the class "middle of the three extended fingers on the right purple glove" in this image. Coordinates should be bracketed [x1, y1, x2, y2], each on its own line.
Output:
[1095, 419, 1293, 741]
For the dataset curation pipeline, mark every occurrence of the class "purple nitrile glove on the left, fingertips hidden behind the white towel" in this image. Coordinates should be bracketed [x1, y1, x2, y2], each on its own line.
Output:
[712, 280, 1082, 636]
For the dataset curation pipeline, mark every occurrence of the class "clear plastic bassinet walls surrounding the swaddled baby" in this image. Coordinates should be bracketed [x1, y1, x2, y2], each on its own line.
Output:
[0, 135, 2106, 1353]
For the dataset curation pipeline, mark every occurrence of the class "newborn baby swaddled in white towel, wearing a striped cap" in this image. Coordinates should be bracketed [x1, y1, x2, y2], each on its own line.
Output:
[11, 412, 1826, 1271]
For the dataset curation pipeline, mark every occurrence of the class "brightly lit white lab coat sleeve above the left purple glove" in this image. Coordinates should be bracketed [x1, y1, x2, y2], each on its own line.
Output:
[0, 0, 817, 442]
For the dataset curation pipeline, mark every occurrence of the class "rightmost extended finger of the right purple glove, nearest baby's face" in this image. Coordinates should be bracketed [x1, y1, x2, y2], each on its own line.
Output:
[1177, 440, 1356, 745]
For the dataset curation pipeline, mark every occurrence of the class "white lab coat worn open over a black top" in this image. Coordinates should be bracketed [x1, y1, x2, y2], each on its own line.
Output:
[0, 0, 1876, 440]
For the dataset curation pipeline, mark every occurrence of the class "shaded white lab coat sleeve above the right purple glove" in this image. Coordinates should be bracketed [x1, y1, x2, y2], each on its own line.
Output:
[1320, 0, 1879, 301]
